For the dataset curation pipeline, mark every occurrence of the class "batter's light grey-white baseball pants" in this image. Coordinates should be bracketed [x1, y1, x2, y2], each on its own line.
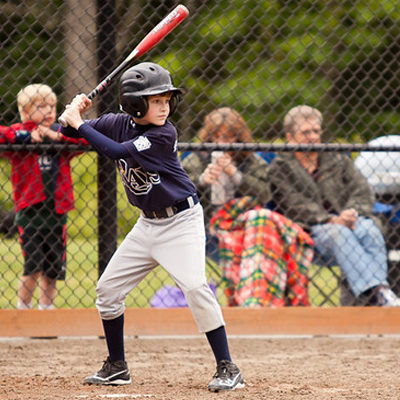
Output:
[96, 203, 225, 332]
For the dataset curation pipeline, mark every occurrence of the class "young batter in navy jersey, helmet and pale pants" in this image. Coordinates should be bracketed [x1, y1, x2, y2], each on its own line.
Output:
[62, 62, 244, 391]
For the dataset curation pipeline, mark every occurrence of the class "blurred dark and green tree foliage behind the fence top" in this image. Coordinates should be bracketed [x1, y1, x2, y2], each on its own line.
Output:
[0, 0, 400, 140]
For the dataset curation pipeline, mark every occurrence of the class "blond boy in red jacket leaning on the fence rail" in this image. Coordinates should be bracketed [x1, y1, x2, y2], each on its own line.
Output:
[0, 84, 87, 310]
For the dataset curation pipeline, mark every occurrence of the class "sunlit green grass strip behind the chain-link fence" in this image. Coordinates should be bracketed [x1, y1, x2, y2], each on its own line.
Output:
[0, 237, 340, 309]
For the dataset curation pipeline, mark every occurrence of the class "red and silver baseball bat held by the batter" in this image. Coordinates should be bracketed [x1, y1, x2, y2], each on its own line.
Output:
[58, 4, 189, 127]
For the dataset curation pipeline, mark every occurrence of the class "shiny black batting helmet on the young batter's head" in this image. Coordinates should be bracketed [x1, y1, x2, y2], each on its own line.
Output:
[119, 62, 183, 118]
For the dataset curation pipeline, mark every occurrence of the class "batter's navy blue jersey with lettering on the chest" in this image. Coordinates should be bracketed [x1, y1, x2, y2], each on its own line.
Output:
[79, 114, 196, 211]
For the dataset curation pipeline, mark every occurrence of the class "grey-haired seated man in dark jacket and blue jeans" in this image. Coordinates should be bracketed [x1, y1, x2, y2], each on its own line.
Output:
[269, 105, 400, 306]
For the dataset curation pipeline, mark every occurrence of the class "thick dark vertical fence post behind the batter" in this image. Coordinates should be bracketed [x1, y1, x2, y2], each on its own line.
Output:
[97, 0, 118, 276]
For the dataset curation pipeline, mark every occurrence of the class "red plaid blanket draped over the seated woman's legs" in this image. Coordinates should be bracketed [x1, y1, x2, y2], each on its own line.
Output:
[210, 196, 314, 308]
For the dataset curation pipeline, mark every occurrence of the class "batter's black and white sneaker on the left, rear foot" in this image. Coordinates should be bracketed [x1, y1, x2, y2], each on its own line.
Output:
[83, 357, 131, 385]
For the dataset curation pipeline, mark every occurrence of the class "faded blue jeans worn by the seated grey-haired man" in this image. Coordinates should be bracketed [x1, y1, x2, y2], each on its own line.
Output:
[311, 217, 388, 296]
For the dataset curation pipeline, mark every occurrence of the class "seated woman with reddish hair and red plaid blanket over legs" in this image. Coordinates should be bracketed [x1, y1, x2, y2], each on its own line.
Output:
[182, 107, 313, 307]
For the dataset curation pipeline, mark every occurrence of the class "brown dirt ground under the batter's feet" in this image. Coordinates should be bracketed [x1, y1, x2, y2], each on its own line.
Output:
[0, 336, 400, 400]
